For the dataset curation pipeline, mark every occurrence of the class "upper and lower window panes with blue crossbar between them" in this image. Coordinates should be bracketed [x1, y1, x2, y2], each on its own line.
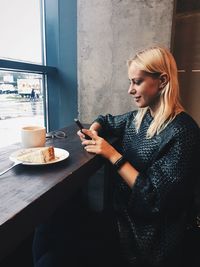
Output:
[0, 0, 55, 147]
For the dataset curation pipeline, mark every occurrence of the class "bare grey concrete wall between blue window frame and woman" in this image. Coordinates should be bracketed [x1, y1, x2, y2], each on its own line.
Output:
[77, 0, 174, 123]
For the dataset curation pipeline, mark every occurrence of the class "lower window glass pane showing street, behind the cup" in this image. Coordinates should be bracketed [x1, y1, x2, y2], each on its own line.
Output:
[0, 70, 44, 147]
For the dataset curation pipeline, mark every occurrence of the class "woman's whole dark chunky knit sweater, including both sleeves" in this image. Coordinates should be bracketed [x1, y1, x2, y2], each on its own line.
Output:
[96, 111, 200, 266]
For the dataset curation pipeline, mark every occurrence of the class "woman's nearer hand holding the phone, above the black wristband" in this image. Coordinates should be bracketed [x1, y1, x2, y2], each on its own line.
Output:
[82, 129, 120, 162]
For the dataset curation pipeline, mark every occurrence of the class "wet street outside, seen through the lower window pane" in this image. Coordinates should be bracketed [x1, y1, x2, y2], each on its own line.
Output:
[0, 94, 44, 147]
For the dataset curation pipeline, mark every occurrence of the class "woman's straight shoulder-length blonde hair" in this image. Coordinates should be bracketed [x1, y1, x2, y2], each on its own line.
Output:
[128, 46, 184, 138]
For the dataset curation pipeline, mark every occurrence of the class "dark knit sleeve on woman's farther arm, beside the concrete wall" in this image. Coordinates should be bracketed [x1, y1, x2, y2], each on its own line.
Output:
[95, 111, 135, 137]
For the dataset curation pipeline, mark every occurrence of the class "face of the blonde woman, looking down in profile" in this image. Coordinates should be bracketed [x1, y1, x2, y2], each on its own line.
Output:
[128, 64, 161, 115]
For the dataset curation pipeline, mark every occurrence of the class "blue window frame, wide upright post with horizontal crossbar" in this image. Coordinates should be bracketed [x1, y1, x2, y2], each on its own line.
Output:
[0, 0, 78, 134]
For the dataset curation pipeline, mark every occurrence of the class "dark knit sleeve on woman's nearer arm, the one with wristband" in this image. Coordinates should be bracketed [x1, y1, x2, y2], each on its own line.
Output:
[129, 121, 200, 218]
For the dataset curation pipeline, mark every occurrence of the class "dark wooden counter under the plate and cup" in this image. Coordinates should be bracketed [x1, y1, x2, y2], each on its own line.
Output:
[0, 125, 111, 260]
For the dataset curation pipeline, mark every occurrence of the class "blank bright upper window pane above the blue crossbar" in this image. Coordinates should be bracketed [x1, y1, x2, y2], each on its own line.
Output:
[0, 0, 42, 64]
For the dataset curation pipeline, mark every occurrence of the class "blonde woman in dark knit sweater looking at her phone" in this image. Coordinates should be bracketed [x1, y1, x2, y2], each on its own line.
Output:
[78, 47, 200, 267]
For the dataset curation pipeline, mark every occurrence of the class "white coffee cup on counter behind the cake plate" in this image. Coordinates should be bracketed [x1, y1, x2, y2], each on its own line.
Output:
[21, 126, 46, 148]
